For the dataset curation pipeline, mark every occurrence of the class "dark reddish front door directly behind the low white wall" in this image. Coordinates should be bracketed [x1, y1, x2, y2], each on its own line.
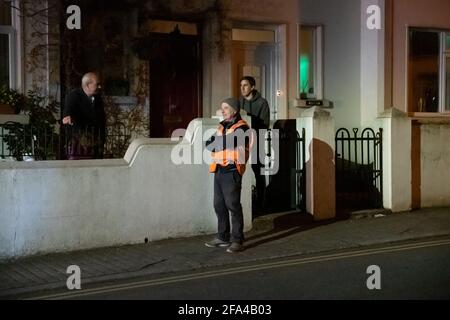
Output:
[150, 33, 202, 138]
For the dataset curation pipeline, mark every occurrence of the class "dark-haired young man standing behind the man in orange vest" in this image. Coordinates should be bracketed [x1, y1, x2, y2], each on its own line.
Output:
[239, 76, 270, 214]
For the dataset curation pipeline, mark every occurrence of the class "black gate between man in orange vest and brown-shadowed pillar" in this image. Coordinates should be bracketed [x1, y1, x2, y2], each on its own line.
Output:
[265, 120, 306, 212]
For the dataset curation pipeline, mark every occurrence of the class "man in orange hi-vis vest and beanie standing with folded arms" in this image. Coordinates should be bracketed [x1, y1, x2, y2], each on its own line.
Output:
[205, 98, 253, 253]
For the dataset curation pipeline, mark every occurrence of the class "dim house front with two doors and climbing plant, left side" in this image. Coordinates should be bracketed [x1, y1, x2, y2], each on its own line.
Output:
[2, 0, 298, 137]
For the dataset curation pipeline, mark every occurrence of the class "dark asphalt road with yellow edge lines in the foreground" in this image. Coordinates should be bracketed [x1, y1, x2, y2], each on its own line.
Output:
[29, 237, 450, 300]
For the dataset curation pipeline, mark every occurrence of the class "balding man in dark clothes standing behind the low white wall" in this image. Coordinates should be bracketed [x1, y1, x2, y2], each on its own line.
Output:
[63, 72, 106, 160]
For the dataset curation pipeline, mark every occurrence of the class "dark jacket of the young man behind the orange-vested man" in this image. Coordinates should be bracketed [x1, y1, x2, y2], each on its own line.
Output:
[239, 90, 270, 130]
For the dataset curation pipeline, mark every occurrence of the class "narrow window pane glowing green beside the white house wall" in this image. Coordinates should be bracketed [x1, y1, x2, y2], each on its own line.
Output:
[299, 26, 315, 98]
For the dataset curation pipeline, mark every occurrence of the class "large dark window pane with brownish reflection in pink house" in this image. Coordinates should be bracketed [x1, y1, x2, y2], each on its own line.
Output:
[408, 30, 440, 112]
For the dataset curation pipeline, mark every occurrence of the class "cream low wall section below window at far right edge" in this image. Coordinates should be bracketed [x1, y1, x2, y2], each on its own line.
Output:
[420, 124, 450, 207]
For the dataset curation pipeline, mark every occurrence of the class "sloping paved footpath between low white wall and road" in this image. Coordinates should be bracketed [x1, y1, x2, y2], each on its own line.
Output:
[0, 208, 450, 299]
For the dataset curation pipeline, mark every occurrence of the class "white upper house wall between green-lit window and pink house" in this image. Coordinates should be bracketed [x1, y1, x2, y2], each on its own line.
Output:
[298, 0, 361, 128]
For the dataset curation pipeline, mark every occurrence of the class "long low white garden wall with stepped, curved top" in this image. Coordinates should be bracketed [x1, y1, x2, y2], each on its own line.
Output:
[0, 119, 252, 259]
